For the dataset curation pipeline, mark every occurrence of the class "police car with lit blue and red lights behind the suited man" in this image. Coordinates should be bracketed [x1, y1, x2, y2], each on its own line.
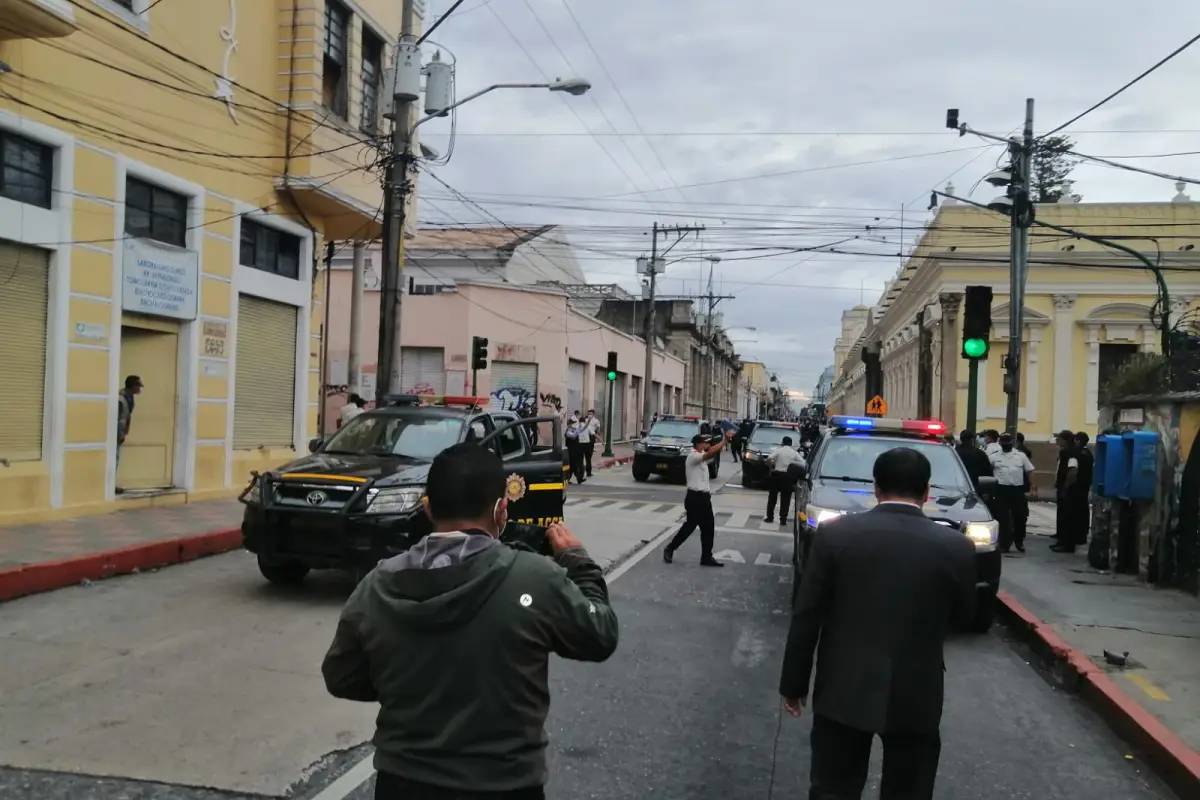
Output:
[792, 416, 1001, 633]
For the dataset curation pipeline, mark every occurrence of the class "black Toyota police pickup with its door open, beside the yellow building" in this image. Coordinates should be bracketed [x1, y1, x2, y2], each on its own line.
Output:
[239, 395, 565, 584]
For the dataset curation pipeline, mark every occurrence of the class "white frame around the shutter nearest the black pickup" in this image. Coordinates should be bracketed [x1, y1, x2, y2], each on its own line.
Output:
[226, 203, 319, 474]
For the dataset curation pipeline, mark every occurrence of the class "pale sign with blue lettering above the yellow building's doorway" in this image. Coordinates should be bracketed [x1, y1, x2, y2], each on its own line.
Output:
[121, 239, 200, 319]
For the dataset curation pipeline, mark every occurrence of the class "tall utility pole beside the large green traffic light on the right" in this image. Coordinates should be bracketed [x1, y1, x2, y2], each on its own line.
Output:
[1004, 97, 1033, 435]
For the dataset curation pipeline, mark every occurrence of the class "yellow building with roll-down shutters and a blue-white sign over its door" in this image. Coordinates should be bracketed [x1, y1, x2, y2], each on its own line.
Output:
[0, 0, 400, 524]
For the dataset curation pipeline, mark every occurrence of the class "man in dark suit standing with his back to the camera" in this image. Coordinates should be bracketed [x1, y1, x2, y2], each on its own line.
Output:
[779, 447, 976, 800]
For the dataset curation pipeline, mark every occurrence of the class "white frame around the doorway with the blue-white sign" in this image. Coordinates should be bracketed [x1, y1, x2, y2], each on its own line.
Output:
[111, 155, 206, 501]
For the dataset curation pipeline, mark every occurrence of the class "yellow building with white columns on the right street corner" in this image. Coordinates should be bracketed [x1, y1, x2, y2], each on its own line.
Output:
[830, 198, 1200, 443]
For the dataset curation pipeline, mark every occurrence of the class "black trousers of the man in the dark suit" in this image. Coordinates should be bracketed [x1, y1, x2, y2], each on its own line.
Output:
[809, 714, 942, 800]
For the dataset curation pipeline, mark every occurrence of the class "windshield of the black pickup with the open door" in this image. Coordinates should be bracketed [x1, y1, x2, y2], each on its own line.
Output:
[323, 414, 463, 461]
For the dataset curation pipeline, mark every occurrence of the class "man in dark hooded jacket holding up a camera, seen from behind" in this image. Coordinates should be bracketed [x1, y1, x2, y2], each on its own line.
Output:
[322, 444, 617, 800]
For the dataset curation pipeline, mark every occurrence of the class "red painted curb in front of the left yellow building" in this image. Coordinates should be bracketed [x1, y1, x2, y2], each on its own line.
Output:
[0, 528, 241, 602]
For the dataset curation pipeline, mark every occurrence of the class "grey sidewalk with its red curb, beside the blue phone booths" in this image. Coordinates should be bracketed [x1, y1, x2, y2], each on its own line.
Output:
[1001, 503, 1200, 796]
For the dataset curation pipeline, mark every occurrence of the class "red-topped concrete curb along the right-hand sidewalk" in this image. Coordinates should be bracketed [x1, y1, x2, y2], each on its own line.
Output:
[998, 591, 1200, 798]
